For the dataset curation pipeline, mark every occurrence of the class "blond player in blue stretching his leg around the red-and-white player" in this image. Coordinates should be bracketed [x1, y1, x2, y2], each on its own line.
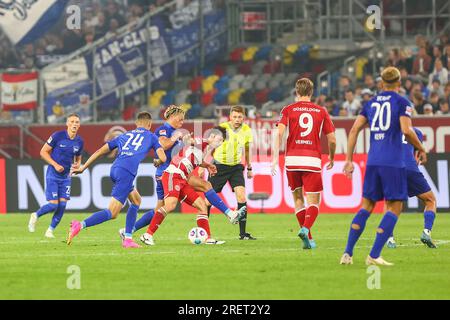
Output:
[124, 106, 246, 244]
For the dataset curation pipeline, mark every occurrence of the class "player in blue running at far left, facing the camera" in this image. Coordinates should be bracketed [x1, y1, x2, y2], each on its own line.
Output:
[28, 114, 84, 238]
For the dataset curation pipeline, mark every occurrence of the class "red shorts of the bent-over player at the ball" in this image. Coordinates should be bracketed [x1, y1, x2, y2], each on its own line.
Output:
[162, 172, 200, 206]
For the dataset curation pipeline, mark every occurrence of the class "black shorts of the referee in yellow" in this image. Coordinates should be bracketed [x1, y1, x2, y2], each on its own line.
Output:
[209, 162, 245, 193]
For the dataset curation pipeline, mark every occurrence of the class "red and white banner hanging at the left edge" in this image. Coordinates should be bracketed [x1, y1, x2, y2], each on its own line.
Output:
[1, 72, 39, 111]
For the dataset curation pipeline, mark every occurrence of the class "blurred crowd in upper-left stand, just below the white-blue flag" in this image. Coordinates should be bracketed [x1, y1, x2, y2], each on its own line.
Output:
[0, 0, 179, 69]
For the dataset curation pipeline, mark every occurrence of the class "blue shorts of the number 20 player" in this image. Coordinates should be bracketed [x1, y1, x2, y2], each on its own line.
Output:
[363, 166, 408, 201]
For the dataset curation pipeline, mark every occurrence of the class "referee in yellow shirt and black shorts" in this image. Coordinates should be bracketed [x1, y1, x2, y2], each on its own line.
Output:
[208, 106, 256, 240]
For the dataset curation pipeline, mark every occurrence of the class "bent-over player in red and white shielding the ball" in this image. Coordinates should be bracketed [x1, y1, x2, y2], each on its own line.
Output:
[141, 127, 246, 245]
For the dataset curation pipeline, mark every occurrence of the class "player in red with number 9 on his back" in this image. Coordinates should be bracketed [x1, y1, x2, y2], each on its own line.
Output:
[272, 79, 336, 249]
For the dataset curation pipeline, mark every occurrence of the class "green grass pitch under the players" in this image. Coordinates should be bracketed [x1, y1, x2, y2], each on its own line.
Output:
[0, 214, 450, 300]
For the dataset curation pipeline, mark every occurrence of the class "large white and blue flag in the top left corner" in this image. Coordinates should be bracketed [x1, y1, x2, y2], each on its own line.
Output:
[0, 0, 69, 45]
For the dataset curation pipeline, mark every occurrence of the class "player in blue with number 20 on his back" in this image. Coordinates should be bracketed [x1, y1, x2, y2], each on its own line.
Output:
[341, 67, 427, 266]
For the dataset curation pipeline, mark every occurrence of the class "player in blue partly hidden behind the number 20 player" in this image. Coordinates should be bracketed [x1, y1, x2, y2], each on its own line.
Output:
[387, 128, 437, 249]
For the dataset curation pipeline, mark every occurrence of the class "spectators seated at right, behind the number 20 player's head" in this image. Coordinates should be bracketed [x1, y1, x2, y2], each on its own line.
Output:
[316, 35, 450, 117]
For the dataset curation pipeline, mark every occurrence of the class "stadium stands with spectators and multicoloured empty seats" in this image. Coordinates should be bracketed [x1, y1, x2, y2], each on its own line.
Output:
[0, 0, 450, 122]
